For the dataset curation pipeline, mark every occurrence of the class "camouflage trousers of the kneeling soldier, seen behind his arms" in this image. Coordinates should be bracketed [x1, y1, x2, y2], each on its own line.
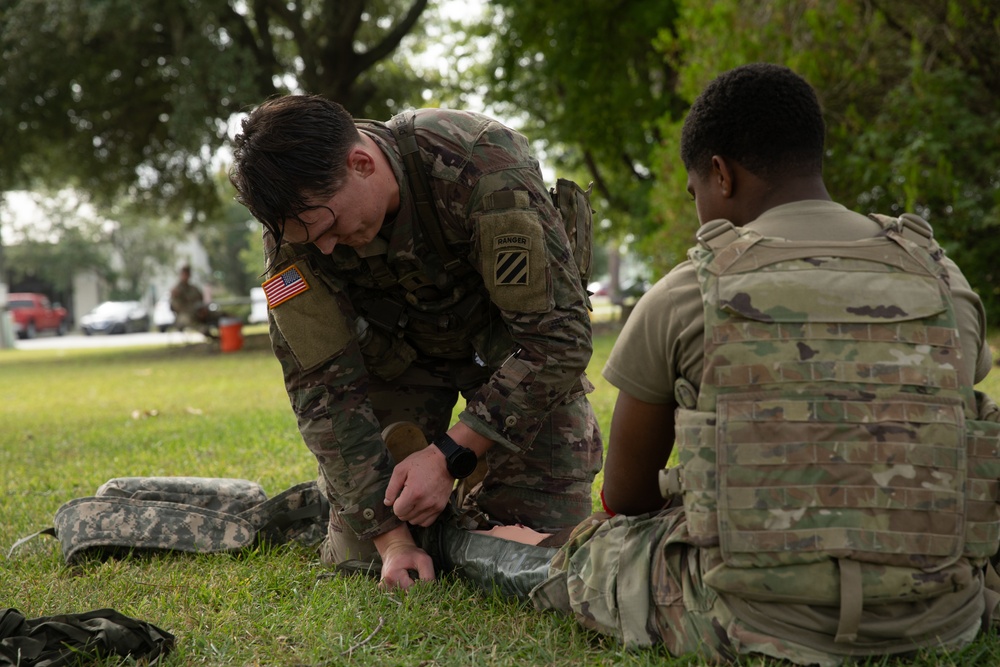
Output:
[320, 360, 604, 562]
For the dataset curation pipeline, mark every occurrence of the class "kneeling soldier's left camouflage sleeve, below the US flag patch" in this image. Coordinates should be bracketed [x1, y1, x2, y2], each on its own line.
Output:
[270, 264, 401, 540]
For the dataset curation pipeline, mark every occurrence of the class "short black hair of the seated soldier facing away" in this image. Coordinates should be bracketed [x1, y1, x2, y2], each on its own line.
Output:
[681, 63, 826, 182]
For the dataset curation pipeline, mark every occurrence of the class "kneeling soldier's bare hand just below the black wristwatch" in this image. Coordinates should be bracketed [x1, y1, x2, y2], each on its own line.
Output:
[385, 447, 455, 527]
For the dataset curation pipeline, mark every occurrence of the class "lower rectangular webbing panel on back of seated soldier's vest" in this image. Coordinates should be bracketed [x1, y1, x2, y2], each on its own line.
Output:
[717, 395, 966, 567]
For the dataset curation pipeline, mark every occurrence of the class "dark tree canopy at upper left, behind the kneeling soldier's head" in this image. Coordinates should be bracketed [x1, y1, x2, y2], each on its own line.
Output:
[0, 0, 438, 213]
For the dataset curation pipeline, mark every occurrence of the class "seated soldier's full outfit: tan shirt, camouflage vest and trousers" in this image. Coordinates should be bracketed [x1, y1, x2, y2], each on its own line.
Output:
[533, 202, 1000, 665]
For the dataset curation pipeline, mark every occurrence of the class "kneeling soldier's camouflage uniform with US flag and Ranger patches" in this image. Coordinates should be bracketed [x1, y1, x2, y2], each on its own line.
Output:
[269, 109, 603, 560]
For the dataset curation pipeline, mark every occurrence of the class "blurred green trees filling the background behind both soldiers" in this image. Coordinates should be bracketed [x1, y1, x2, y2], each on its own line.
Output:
[0, 0, 1000, 323]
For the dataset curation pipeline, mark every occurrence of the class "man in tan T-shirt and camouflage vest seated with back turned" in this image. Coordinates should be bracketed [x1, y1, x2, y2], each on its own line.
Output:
[422, 64, 1000, 665]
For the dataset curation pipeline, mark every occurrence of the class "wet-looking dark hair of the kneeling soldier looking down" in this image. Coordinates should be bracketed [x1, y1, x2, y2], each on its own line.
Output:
[229, 95, 361, 248]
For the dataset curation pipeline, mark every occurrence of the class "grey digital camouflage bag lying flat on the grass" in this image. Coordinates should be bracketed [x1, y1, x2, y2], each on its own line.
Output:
[11, 477, 329, 563]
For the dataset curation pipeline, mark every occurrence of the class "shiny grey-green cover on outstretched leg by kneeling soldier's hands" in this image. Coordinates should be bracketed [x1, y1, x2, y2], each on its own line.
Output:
[419, 520, 558, 600]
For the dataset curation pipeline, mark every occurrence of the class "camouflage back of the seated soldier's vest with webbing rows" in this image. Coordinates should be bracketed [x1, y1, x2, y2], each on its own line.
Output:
[678, 226, 975, 569]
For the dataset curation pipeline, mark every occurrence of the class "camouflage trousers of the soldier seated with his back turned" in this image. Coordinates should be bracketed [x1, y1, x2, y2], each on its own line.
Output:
[531, 507, 984, 667]
